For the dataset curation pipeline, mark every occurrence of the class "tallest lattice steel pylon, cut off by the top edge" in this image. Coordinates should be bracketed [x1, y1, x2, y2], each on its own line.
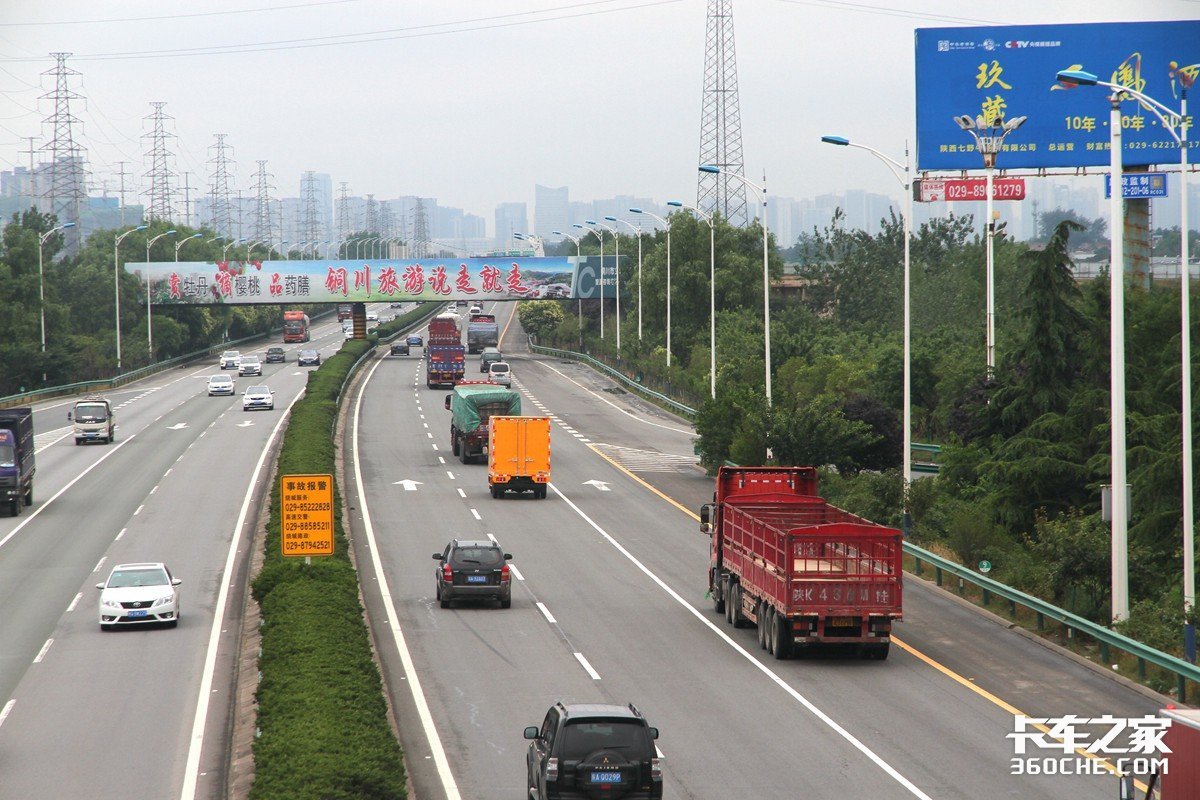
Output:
[696, 0, 750, 227]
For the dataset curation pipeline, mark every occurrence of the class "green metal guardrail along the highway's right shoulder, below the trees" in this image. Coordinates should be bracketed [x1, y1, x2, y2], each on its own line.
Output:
[529, 342, 1200, 703]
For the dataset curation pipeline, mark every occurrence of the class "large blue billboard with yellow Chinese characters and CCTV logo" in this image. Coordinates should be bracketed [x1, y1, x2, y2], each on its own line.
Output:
[917, 19, 1200, 170]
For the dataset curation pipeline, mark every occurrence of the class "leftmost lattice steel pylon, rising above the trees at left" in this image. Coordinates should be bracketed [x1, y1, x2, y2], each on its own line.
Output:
[38, 53, 88, 254]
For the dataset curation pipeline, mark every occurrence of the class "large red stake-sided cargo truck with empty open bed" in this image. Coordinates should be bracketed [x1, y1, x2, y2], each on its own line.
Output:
[700, 467, 904, 660]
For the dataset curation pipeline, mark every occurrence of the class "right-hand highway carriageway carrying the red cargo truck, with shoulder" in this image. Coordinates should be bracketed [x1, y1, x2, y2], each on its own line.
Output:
[346, 305, 1163, 800]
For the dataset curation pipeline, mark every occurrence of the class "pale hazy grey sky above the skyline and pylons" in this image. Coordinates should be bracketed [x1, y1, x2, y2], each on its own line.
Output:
[0, 0, 1200, 219]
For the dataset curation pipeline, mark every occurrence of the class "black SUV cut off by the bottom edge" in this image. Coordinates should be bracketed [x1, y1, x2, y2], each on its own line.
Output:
[524, 703, 662, 800]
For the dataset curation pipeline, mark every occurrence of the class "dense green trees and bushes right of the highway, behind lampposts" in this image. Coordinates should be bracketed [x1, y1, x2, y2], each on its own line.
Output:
[540, 211, 1200, 655]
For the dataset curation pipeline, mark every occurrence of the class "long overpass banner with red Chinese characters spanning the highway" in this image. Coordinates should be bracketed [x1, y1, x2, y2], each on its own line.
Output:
[125, 255, 585, 306]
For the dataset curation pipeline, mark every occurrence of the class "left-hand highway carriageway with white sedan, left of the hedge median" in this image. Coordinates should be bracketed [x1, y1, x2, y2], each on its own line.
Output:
[0, 306, 390, 800]
